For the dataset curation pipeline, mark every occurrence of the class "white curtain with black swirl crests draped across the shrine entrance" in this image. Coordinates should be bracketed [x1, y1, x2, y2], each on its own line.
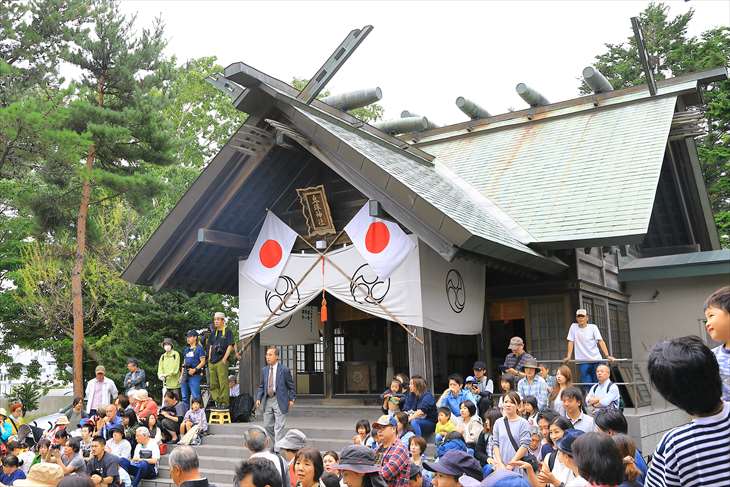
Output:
[238, 235, 485, 345]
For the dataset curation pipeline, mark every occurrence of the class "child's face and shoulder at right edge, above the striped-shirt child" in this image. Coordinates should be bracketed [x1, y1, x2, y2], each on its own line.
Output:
[705, 286, 730, 401]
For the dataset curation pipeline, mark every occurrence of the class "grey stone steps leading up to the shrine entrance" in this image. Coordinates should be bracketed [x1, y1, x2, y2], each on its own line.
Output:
[142, 399, 380, 487]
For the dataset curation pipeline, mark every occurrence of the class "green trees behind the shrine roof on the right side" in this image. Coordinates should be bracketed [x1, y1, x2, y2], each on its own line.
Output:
[580, 3, 730, 248]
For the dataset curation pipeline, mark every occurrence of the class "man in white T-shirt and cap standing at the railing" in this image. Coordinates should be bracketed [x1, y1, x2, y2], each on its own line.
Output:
[564, 309, 616, 390]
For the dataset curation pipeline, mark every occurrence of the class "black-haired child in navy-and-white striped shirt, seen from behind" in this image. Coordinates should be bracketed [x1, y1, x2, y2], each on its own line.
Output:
[644, 336, 730, 487]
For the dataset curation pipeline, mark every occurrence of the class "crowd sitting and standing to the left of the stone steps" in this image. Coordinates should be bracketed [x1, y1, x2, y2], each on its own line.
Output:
[0, 313, 239, 487]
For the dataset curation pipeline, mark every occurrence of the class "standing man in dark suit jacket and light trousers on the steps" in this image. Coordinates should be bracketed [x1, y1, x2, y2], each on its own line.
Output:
[256, 346, 297, 452]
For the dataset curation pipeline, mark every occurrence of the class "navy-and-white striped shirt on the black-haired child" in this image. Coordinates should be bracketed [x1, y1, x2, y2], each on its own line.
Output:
[644, 402, 730, 487]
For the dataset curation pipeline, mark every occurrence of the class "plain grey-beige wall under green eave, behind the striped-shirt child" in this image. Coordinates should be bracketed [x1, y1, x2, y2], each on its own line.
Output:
[626, 276, 730, 361]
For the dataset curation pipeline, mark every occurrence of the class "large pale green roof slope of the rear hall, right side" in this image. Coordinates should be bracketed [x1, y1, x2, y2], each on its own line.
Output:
[421, 95, 676, 248]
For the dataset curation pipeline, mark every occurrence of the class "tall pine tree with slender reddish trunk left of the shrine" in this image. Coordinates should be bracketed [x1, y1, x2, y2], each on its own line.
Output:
[62, 0, 173, 395]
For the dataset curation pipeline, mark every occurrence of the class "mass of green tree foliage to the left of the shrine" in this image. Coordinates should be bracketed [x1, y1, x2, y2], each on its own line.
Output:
[0, 0, 245, 391]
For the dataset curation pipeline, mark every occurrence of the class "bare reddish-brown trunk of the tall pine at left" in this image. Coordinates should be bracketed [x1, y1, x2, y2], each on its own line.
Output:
[71, 77, 104, 397]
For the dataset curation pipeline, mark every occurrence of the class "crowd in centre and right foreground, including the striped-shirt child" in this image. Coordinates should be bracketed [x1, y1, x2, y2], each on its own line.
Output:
[226, 287, 730, 487]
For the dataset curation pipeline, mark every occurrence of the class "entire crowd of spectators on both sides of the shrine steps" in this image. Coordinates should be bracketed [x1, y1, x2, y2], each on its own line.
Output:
[0, 287, 730, 487]
